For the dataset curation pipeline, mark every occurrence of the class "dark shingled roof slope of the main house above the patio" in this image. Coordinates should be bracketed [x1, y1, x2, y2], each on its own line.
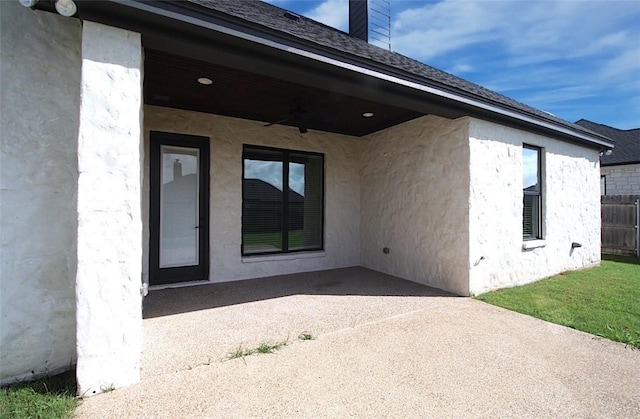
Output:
[189, 0, 608, 143]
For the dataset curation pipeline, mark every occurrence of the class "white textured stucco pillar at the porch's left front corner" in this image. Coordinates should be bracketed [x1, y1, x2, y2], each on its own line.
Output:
[76, 21, 143, 395]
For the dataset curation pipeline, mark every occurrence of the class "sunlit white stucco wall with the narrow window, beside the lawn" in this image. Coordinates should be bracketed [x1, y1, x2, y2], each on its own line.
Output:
[469, 119, 600, 294]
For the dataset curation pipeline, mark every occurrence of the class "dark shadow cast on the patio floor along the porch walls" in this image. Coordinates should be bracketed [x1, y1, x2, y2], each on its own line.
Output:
[143, 267, 457, 319]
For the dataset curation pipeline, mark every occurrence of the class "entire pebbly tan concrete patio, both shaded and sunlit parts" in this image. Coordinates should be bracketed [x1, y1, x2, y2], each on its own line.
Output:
[77, 268, 640, 418]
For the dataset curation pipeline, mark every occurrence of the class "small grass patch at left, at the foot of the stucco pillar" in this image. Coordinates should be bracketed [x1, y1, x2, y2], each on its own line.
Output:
[0, 371, 78, 419]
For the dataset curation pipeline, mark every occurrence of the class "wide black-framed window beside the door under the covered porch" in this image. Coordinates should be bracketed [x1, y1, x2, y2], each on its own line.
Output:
[242, 146, 324, 255]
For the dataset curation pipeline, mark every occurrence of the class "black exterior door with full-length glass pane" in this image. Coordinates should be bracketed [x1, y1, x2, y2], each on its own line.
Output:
[149, 131, 209, 285]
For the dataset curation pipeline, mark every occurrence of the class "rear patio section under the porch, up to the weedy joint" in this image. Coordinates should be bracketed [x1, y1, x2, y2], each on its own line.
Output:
[142, 268, 456, 379]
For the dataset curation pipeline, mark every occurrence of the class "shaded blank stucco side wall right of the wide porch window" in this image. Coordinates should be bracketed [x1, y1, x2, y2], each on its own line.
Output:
[361, 116, 469, 295]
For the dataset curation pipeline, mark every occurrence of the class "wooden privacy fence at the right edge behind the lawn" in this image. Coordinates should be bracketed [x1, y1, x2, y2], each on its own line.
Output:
[600, 195, 640, 256]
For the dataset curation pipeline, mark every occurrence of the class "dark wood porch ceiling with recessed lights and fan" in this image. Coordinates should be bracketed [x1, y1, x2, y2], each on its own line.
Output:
[144, 49, 424, 136]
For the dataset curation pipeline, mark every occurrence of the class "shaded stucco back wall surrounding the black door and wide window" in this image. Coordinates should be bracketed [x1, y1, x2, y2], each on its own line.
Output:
[143, 106, 360, 282]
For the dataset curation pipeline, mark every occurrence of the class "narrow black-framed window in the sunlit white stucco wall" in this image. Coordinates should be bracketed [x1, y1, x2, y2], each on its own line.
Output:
[522, 145, 542, 240]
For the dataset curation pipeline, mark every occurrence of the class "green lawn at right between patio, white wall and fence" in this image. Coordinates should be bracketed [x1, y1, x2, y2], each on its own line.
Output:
[476, 255, 640, 348]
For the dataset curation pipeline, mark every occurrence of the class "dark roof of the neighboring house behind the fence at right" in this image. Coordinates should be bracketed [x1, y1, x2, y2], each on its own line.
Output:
[576, 119, 640, 166]
